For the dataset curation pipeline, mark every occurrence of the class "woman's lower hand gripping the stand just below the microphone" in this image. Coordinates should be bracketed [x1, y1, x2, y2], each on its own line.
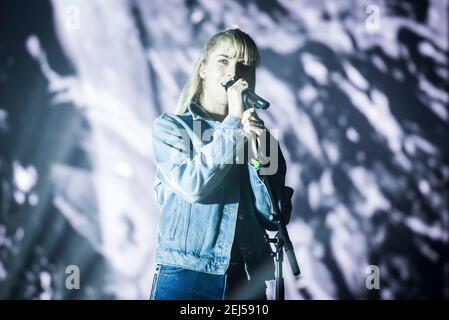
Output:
[242, 108, 267, 163]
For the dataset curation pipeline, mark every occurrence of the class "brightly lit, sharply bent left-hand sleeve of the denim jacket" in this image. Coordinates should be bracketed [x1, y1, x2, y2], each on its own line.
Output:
[153, 113, 246, 203]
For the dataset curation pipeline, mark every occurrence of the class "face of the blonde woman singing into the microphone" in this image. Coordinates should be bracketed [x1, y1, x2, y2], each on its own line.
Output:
[199, 43, 256, 107]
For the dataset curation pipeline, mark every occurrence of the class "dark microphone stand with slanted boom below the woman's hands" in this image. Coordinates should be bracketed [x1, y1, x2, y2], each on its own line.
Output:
[260, 175, 301, 300]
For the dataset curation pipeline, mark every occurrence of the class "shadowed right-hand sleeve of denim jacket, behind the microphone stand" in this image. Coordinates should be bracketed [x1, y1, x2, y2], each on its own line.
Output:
[249, 134, 293, 231]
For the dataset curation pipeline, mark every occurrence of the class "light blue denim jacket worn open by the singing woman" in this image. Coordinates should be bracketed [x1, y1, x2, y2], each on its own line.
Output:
[153, 103, 286, 274]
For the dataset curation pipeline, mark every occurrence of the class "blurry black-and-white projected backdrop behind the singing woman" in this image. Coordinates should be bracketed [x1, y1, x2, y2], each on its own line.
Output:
[0, 0, 449, 299]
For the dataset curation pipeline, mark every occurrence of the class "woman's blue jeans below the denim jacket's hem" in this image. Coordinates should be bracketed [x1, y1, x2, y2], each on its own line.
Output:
[150, 265, 226, 300]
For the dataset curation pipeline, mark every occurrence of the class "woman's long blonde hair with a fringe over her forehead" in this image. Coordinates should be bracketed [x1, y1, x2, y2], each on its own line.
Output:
[175, 28, 260, 114]
